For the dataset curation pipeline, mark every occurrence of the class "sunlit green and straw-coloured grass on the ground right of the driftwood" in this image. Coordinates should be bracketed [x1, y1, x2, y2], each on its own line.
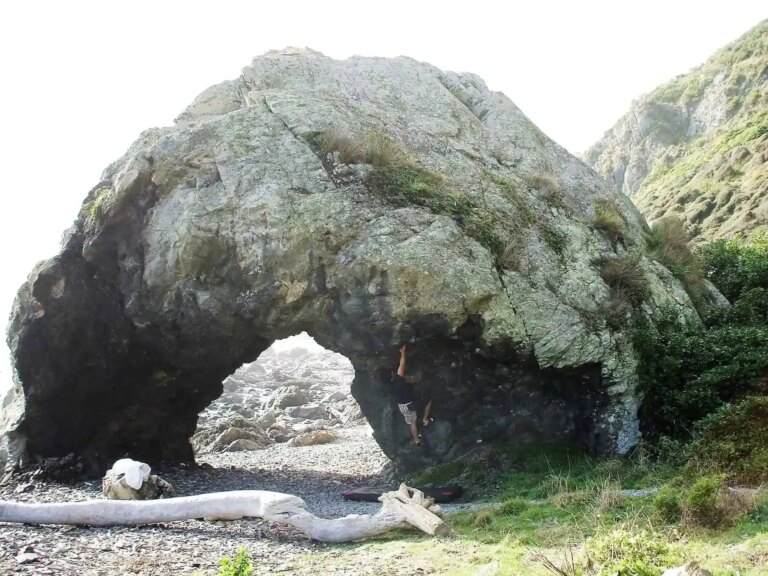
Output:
[286, 444, 768, 576]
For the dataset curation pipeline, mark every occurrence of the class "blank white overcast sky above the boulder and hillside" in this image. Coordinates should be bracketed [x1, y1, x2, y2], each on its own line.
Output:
[0, 0, 768, 390]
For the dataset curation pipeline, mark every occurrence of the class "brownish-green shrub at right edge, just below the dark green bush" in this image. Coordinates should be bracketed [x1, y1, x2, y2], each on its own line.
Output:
[693, 396, 768, 485]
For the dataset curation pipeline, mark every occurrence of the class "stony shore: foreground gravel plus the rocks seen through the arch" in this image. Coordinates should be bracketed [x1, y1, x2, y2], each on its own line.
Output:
[0, 344, 480, 576]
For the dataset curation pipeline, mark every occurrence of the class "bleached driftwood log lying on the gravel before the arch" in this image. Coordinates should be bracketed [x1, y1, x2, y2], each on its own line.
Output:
[0, 484, 449, 542]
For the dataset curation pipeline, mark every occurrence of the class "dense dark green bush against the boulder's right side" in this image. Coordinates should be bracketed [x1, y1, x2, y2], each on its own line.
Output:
[633, 232, 768, 439]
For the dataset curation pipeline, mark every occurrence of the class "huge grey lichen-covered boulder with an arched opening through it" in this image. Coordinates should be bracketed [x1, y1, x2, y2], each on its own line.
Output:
[3, 50, 695, 467]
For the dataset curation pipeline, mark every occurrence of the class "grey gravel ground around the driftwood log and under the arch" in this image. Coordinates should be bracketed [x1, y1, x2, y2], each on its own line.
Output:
[0, 426, 480, 576]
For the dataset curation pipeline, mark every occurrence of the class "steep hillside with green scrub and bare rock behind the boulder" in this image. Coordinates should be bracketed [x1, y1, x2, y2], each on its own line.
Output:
[585, 20, 768, 239]
